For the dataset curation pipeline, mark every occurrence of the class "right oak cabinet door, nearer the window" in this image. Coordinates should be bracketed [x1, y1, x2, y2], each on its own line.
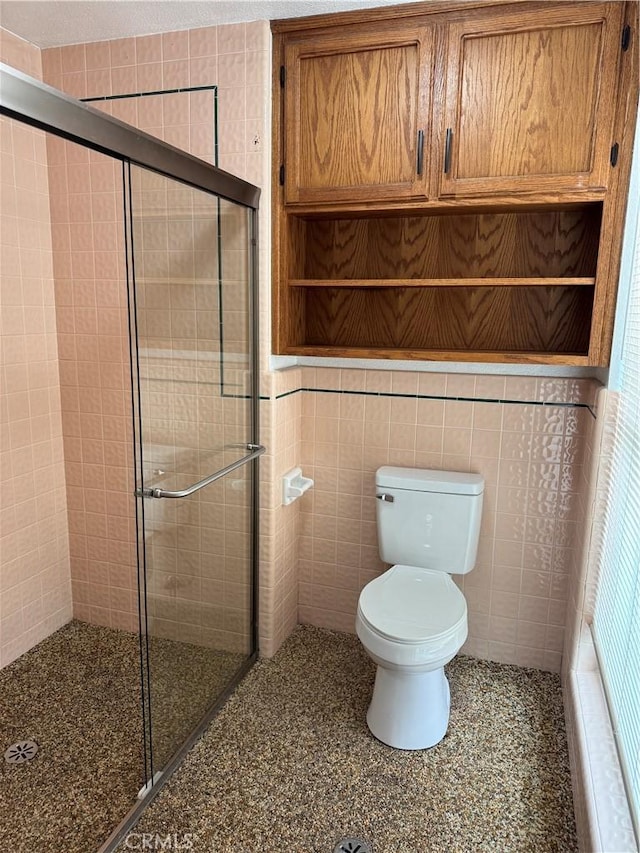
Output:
[440, 3, 622, 196]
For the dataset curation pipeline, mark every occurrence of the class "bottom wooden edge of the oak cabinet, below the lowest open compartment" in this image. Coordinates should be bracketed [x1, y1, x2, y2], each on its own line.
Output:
[277, 344, 589, 367]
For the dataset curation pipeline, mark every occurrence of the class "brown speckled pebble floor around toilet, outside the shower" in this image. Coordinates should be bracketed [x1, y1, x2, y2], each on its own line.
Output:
[120, 627, 577, 853]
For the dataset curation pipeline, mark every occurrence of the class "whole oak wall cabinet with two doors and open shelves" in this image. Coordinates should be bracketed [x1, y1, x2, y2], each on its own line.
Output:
[273, 2, 638, 365]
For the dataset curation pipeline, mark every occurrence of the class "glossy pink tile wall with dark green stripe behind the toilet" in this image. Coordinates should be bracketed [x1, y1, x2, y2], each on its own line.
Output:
[292, 368, 595, 671]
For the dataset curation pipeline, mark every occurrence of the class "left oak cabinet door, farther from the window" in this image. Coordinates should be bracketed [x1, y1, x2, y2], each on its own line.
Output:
[284, 29, 432, 202]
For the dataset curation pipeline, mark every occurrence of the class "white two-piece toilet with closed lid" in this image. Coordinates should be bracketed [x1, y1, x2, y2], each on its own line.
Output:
[356, 466, 484, 749]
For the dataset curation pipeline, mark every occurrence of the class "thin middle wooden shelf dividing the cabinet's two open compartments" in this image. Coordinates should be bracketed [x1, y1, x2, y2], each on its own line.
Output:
[288, 276, 596, 287]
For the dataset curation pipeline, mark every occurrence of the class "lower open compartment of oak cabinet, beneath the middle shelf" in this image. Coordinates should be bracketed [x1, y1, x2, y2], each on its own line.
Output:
[302, 285, 594, 355]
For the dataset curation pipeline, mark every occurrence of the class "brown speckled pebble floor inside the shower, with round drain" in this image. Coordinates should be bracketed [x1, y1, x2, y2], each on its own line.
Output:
[0, 621, 241, 853]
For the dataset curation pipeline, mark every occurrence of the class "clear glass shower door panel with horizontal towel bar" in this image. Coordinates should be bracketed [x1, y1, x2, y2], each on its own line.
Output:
[126, 165, 261, 779]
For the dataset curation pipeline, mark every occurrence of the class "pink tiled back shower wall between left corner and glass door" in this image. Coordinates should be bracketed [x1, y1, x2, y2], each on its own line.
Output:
[45, 130, 137, 630]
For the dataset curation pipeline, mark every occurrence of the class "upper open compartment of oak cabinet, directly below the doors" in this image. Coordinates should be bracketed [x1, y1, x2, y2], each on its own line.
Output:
[288, 202, 602, 286]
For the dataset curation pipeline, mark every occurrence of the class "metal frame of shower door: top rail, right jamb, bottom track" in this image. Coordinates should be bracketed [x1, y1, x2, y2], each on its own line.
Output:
[0, 63, 264, 853]
